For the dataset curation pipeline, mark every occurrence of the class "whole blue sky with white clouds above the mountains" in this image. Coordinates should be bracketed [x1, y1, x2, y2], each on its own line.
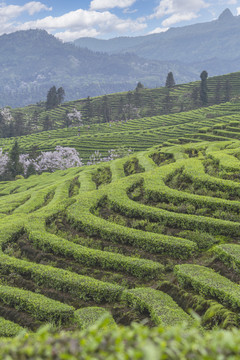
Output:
[0, 0, 240, 41]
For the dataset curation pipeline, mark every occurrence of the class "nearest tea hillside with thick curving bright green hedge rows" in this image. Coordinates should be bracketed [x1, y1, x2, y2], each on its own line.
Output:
[0, 139, 240, 336]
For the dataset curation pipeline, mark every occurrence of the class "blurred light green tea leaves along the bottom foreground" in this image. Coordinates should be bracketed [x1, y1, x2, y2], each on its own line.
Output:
[3, 319, 240, 360]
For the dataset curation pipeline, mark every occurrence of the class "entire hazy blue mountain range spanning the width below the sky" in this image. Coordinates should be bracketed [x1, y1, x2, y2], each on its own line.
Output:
[0, 10, 240, 107]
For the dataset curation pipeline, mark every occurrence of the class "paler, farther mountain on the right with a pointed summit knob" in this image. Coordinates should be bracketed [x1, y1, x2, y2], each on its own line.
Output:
[75, 9, 240, 71]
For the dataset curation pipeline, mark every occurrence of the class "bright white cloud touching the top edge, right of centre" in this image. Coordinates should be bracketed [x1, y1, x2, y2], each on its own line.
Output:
[150, 0, 209, 27]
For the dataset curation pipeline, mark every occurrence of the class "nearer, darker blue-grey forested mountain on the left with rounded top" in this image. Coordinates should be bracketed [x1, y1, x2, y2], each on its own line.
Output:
[0, 30, 198, 107]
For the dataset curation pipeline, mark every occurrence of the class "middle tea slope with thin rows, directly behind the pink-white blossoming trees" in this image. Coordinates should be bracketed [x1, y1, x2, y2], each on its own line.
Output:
[0, 101, 240, 163]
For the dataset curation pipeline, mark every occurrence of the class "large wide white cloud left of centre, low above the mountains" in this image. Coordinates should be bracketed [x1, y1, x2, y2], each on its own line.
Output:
[15, 9, 147, 41]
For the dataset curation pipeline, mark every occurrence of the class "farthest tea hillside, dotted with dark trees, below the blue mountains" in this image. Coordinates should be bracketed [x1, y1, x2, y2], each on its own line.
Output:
[7, 72, 240, 136]
